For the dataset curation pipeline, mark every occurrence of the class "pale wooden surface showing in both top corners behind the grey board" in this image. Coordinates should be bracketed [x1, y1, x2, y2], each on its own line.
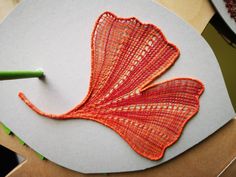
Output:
[0, 0, 215, 33]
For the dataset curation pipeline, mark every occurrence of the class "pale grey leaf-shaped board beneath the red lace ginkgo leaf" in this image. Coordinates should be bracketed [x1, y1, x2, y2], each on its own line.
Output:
[0, 0, 234, 173]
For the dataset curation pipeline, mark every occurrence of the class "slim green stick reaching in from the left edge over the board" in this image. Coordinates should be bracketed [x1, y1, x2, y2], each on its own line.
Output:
[0, 70, 44, 80]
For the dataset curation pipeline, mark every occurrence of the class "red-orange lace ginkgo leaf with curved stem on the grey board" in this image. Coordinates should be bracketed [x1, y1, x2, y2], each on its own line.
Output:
[19, 12, 204, 160]
